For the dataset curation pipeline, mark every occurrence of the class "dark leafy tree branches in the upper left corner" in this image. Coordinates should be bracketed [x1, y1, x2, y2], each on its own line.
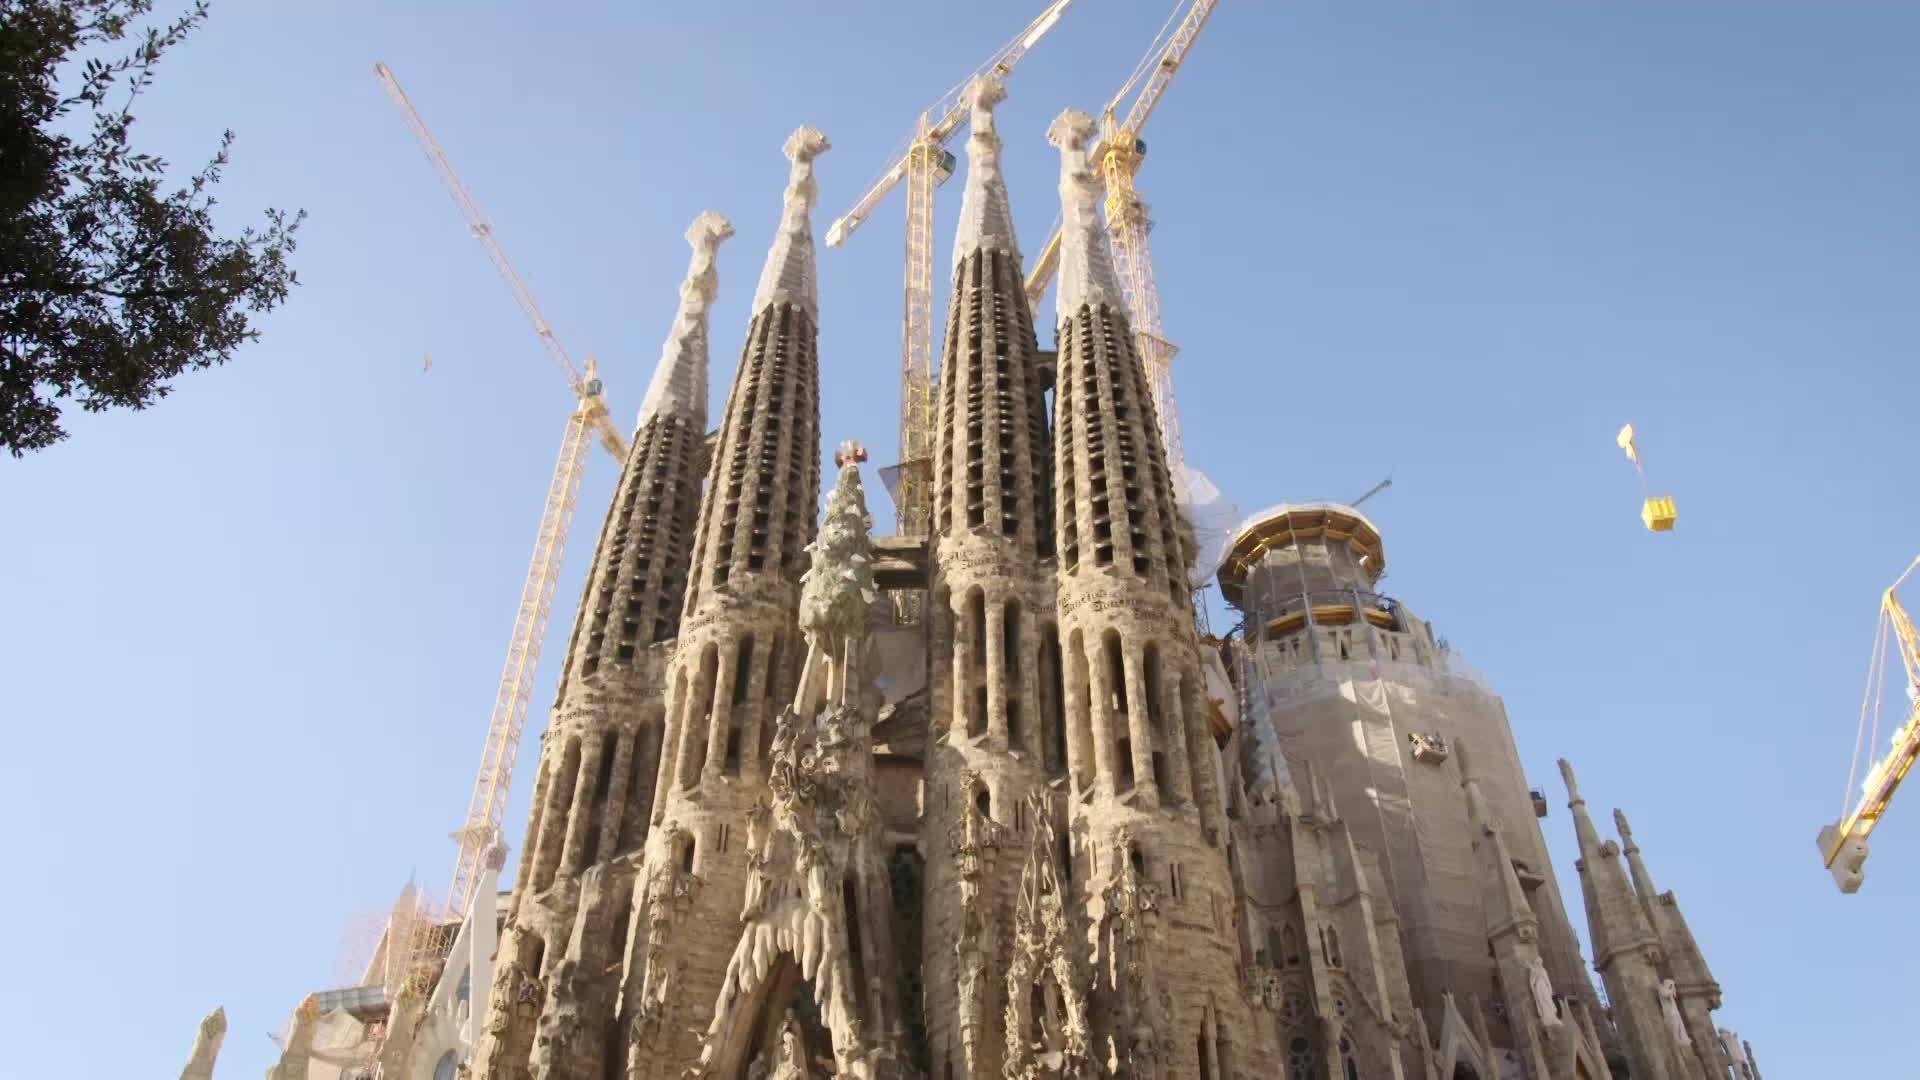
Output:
[0, 0, 305, 457]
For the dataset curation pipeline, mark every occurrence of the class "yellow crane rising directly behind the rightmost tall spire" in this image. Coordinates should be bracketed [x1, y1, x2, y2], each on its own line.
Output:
[1027, 0, 1219, 484]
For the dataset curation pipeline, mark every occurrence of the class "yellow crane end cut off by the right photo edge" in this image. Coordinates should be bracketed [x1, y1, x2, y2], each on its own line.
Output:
[1820, 557, 1920, 892]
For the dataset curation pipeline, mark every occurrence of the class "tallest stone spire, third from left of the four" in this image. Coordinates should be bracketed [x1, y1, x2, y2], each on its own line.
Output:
[922, 79, 1066, 1076]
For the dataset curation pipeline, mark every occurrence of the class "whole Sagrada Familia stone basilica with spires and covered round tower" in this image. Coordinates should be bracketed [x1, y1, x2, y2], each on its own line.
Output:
[217, 81, 1759, 1080]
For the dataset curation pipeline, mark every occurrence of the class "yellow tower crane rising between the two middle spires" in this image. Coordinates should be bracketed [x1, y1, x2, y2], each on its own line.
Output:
[828, 0, 1071, 536]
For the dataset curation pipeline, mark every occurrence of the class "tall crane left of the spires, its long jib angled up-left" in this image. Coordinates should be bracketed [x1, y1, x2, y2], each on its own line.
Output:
[372, 63, 626, 922]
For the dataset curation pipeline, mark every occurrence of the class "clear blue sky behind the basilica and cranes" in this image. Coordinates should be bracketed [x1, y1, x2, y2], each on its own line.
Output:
[0, 0, 1920, 1078]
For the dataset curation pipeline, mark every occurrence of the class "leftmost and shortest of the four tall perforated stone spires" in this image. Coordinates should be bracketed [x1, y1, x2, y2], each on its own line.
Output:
[474, 211, 733, 1080]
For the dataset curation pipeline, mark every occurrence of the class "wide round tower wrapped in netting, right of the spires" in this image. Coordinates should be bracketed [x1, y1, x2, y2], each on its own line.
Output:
[1219, 503, 1599, 1028]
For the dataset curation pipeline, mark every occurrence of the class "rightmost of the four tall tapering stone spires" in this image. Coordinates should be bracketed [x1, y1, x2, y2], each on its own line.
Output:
[1048, 111, 1261, 1076]
